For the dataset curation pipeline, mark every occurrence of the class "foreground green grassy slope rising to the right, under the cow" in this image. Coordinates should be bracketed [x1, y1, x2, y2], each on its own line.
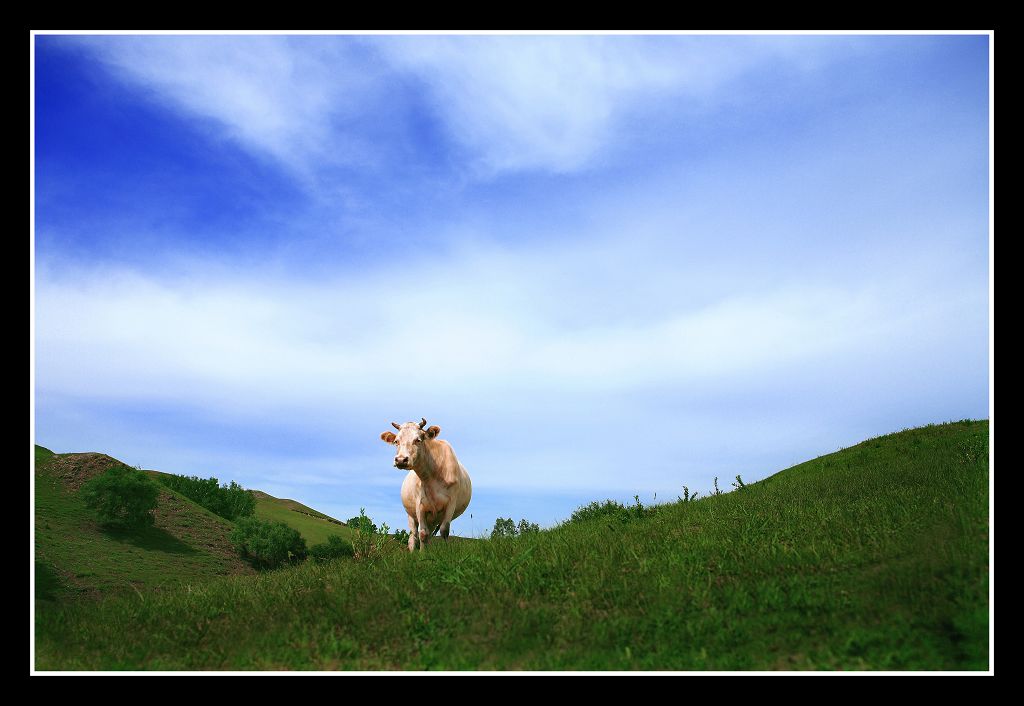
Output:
[36, 421, 989, 670]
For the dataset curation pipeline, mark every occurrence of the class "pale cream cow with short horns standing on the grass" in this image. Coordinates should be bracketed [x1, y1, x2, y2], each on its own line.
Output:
[381, 417, 473, 551]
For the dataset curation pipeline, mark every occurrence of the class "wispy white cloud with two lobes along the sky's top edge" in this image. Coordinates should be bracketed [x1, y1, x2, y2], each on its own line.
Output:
[70, 35, 839, 177]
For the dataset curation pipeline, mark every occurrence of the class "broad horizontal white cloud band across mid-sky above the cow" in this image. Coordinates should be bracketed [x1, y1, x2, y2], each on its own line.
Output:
[37, 224, 963, 434]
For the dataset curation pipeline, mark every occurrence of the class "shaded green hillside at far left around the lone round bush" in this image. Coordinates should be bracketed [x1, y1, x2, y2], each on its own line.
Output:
[35, 447, 254, 601]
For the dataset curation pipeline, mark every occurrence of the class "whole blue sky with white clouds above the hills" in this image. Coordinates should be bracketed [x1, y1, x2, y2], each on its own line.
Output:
[35, 35, 990, 534]
